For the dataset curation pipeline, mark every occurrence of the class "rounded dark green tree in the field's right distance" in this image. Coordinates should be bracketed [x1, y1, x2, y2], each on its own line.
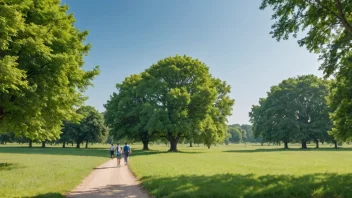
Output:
[250, 75, 331, 148]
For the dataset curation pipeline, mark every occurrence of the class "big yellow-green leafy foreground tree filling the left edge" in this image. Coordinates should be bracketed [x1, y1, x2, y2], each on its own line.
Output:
[0, 0, 99, 141]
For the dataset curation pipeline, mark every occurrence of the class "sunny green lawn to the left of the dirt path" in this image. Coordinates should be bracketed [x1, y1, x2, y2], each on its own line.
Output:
[0, 144, 109, 198]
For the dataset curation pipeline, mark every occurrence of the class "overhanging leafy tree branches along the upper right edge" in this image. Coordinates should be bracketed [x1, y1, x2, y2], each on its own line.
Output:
[260, 0, 352, 140]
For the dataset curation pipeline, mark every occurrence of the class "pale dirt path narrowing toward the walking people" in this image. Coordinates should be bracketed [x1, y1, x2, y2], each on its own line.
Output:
[67, 158, 148, 198]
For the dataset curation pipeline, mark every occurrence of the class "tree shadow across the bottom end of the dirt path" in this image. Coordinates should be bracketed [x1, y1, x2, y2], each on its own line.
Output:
[66, 185, 148, 198]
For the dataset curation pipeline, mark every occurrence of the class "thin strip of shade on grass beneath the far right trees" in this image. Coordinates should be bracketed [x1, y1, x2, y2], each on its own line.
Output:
[224, 148, 352, 153]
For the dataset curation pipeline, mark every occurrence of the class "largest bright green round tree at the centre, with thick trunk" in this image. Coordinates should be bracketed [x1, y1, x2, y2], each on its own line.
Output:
[140, 56, 234, 151]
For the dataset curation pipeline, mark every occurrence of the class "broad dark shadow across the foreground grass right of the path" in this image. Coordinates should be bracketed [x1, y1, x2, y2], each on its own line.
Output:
[141, 173, 352, 198]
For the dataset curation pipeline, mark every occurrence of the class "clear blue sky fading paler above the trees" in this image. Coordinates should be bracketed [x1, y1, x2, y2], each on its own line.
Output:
[63, 0, 322, 124]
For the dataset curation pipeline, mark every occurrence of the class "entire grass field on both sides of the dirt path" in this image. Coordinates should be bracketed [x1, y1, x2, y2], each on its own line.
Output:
[0, 144, 352, 197]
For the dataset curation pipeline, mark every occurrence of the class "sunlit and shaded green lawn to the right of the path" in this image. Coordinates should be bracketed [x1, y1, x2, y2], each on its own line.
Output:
[130, 145, 352, 197]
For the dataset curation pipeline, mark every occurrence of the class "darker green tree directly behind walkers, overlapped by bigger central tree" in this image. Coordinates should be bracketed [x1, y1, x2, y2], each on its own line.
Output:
[105, 75, 157, 150]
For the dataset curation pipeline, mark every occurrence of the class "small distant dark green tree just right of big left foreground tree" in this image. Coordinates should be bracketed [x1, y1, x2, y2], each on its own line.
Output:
[61, 106, 108, 148]
